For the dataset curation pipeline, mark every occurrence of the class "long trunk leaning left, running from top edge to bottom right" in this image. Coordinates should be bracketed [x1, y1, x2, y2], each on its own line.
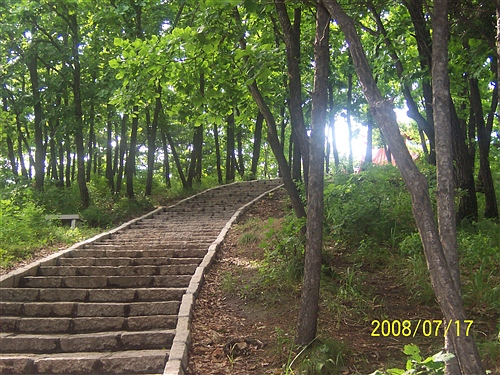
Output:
[323, 0, 485, 375]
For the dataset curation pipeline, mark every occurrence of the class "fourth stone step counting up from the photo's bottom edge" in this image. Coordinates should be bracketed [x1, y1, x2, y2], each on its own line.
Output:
[0, 301, 180, 318]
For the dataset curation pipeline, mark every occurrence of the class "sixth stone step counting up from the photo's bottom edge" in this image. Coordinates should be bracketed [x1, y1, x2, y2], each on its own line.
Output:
[19, 275, 191, 289]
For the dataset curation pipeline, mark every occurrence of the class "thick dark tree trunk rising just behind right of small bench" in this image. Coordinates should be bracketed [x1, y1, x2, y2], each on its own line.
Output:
[68, 12, 90, 208]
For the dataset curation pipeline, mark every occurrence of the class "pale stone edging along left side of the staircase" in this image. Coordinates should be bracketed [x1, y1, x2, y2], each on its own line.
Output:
[0, 179, 281, 288]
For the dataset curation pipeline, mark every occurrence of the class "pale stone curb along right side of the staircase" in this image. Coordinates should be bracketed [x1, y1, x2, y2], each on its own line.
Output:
[163, 184, 283, 375]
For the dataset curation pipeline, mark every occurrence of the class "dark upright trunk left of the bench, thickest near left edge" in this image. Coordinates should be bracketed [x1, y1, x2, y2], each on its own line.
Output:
[26, 51, 45, 190]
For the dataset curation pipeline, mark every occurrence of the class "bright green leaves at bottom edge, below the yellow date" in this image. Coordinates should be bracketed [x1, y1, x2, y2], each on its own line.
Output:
[370, 344, 455, 375]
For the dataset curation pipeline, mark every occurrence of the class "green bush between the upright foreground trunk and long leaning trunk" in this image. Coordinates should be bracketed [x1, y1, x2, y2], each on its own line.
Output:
[325, 166, 415, 247]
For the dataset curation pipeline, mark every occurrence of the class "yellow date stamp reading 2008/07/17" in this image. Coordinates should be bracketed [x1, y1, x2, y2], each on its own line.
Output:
[371, 319, 474, 337]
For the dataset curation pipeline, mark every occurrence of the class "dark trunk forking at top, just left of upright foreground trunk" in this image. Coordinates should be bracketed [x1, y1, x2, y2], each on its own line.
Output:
[274, 0, 309, 186]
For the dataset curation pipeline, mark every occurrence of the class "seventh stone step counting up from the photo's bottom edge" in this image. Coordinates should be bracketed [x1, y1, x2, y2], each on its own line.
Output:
[37, 264, 197, 276]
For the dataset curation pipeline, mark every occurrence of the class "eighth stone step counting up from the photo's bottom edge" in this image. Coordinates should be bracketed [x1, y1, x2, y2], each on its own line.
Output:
[57, 257, 203, 267]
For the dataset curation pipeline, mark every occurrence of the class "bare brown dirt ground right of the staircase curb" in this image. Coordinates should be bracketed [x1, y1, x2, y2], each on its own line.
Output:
[187, 192, 500, 375]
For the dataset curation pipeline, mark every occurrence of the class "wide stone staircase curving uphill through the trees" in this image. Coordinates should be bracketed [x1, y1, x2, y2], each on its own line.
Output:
[0, 180, 280, 374]
